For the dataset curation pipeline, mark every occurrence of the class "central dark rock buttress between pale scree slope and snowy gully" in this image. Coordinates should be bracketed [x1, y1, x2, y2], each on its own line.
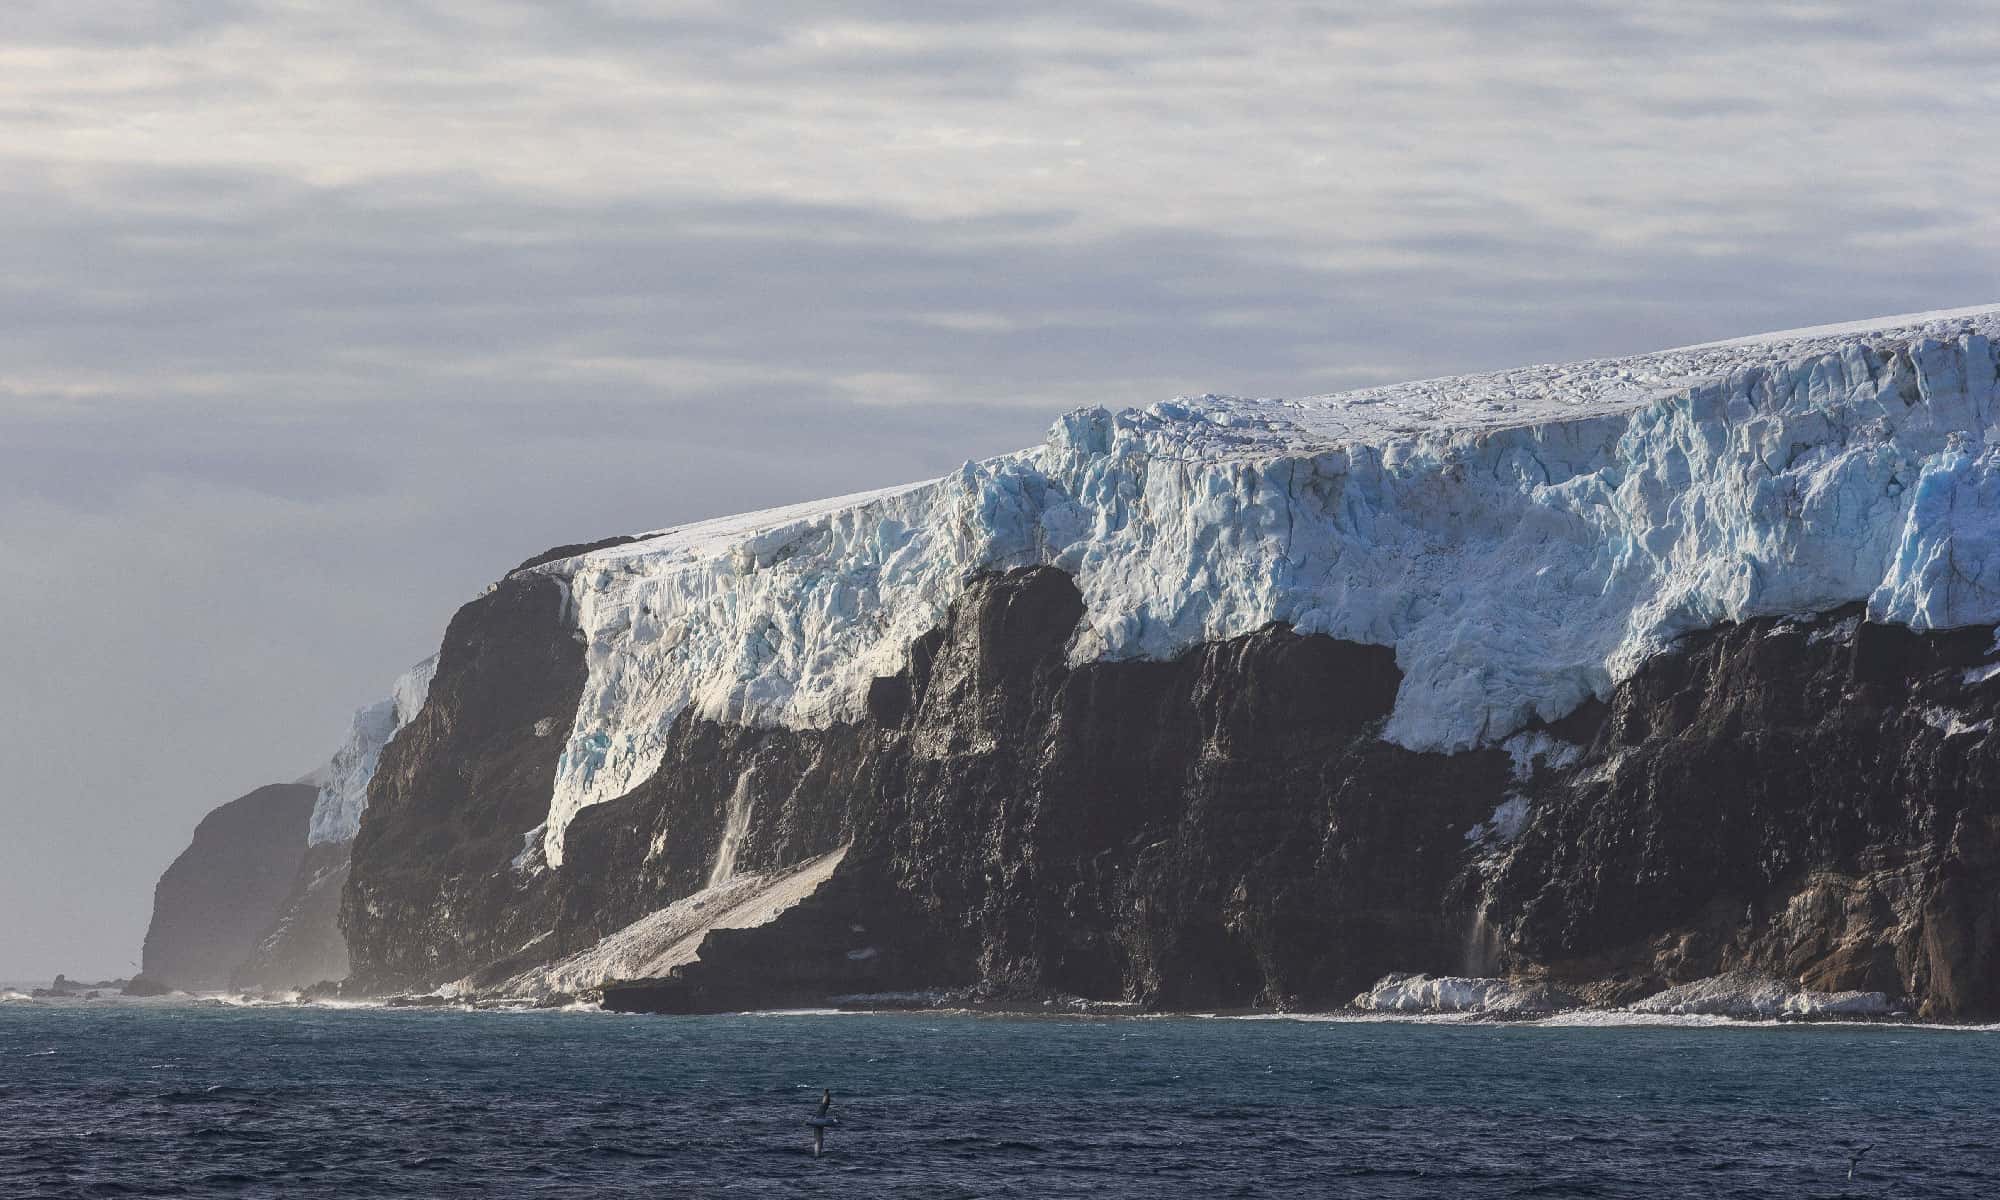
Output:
[848, 568, 1506, 1008]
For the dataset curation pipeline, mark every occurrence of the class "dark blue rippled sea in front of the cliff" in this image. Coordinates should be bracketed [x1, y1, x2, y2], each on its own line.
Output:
[0, 1002, 2000, 1200]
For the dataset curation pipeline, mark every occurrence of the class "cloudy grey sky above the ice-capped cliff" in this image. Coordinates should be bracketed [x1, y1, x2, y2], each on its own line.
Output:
[0, 0, 2000, 980]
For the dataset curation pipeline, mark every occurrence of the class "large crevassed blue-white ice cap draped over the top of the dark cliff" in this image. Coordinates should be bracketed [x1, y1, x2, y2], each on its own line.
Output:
[534, 308, 2000, 866]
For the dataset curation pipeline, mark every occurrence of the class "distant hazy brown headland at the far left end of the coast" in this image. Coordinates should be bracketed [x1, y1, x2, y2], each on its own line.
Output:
[142, 784, 318, 992]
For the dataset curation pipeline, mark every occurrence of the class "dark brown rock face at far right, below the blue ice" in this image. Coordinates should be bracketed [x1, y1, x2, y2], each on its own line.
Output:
[1474, 608, 2000, 1018]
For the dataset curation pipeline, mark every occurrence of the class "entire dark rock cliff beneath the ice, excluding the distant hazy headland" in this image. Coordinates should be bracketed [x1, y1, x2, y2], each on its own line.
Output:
[344, 568, 2000, 1018]
